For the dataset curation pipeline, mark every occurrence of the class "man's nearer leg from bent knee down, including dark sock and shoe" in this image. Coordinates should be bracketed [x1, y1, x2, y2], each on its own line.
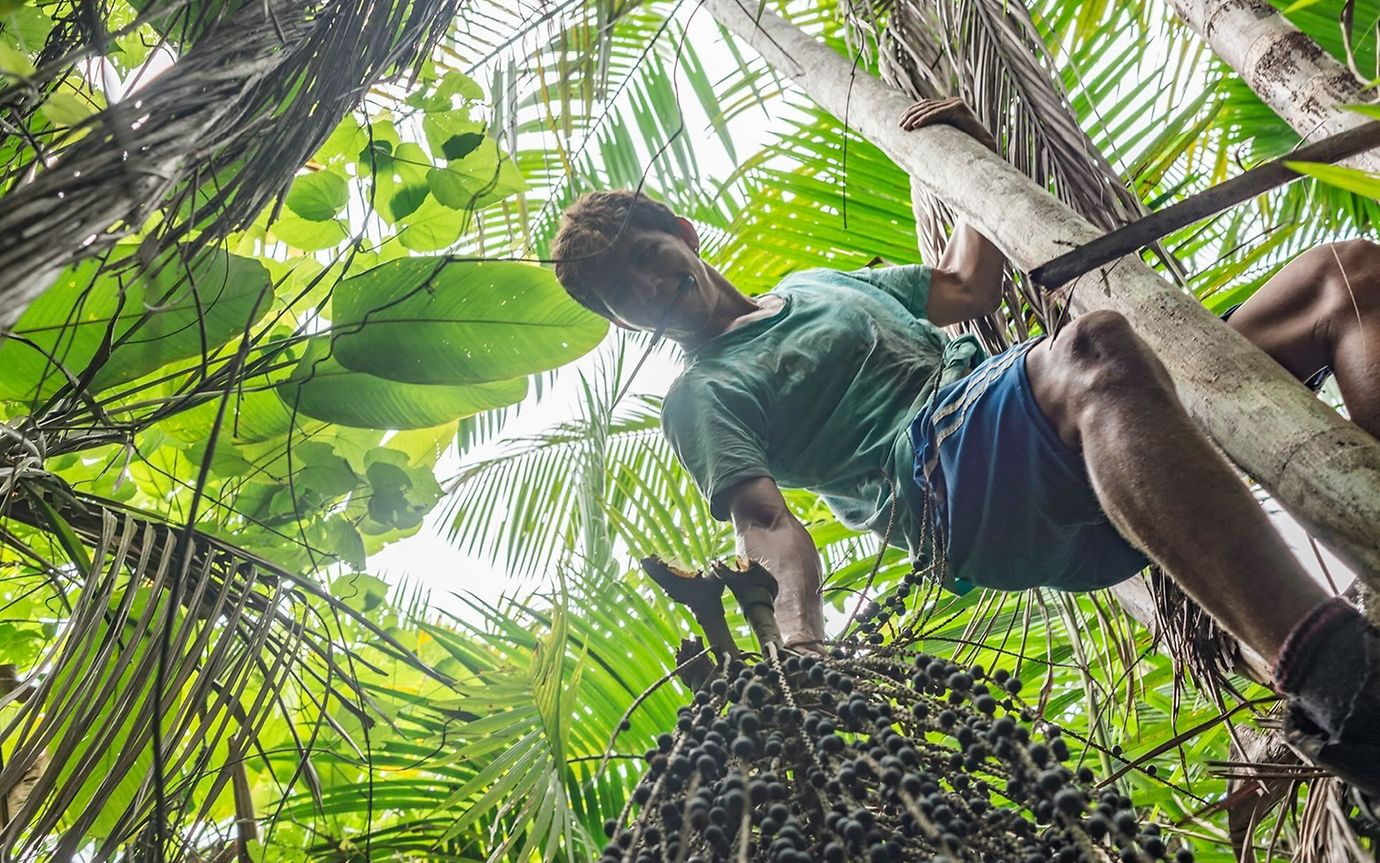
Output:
[1025, 312, 1380, 806]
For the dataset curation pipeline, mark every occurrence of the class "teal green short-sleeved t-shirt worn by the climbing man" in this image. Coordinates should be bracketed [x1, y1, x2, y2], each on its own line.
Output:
[661, 265, 983, 556]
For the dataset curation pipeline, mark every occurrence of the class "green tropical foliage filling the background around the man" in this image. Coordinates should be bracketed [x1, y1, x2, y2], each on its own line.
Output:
[0, 0, 1380, 860]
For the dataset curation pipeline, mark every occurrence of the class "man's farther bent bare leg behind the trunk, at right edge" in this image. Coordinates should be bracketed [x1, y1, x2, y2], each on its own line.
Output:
[1227, 240, 1380, 438]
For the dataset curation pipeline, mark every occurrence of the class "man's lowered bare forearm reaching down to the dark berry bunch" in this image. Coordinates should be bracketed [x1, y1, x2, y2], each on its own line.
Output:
[723, 476, 824, 646]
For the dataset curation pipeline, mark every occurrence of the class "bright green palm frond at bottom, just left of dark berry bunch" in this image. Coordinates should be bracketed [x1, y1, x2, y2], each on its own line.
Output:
[282, 557, 686, 860]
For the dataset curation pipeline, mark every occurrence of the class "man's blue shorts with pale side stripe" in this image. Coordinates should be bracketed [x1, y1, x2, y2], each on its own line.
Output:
[911, 341, 1150, 592]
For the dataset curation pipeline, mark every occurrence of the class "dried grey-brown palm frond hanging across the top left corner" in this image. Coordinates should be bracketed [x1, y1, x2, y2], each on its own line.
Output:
[0, 0, 457, 323]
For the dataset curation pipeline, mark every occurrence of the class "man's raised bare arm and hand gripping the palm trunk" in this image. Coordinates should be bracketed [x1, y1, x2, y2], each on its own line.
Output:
[901, 98, 1006, 327]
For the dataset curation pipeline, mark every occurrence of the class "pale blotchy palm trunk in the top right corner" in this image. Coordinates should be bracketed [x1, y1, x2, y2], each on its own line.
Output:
[1169, 0, 1380, 171]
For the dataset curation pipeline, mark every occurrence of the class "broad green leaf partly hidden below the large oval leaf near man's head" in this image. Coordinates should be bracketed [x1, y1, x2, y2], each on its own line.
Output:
[277, 338, 527, 429]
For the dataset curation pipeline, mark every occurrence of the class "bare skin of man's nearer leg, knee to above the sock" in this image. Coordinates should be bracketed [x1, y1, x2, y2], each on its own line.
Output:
[1025, 312, 1328, 657]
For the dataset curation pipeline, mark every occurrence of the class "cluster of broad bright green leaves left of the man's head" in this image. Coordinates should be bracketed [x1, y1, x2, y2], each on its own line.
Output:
[0, 69, 607, 579]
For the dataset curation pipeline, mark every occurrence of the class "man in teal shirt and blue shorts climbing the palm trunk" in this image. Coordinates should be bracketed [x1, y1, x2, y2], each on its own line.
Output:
[552, 99, 1380, 795]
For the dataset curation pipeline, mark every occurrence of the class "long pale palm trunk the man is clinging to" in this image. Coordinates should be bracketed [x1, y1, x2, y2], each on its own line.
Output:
[707, 0, 1380, 588]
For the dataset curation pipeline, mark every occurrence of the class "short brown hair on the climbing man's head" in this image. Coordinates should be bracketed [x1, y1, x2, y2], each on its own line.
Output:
[551, 189, 680, 318]
